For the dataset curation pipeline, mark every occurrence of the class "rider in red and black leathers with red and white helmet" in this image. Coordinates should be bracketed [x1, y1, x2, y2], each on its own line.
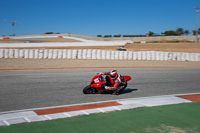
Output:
[105, 70, 121, 94]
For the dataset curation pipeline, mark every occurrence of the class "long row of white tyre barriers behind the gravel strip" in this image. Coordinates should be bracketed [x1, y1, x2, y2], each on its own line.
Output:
[0, 49, 200, 61]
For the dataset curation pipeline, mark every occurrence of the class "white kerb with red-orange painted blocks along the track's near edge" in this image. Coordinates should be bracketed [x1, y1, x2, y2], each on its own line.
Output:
[0, 93, 200, 126]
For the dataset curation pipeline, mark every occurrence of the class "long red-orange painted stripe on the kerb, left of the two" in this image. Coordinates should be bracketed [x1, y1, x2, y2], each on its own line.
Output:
[34, 102, 122, 115]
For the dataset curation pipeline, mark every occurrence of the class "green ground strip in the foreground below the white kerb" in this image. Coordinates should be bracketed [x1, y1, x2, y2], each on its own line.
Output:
[0, 102, 200, 133]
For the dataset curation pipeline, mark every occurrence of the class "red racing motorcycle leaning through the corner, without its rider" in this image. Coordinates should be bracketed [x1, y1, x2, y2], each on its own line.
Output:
[83, 73, 131, 94]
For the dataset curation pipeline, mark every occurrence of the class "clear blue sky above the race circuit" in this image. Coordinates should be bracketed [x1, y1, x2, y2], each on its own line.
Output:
[0, 0, 200, 36]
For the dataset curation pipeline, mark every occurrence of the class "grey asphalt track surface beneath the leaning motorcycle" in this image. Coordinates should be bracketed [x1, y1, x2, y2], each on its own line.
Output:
[0, 68, 200, 112]
